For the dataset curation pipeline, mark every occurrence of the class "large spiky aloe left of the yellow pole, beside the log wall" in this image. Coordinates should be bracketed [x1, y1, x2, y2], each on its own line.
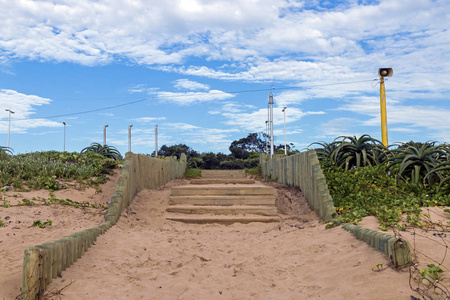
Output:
[330, 134, 388, 170]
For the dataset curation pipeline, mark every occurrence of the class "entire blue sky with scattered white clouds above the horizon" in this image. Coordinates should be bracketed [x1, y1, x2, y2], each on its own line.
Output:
[0, 0, 450, 153]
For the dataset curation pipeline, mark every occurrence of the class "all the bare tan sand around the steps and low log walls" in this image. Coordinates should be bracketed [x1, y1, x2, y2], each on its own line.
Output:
[0, 176, 450, 299]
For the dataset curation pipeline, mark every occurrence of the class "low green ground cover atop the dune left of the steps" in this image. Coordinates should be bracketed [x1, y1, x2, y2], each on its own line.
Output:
[0, 151, 118, 191]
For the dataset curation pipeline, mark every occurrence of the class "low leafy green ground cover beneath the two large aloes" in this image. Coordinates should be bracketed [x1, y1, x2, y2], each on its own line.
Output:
[323, 165, 450, 229]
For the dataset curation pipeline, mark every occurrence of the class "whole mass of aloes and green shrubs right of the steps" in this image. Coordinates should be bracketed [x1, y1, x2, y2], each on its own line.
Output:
[311, 135, 450, 230]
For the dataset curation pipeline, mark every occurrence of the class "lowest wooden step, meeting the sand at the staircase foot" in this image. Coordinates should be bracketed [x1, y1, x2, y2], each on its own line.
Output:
[166, 213, 280, 224]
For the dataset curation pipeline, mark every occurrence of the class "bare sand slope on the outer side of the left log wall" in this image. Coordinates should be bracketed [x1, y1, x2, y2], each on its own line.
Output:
[0, 170, 120, 300]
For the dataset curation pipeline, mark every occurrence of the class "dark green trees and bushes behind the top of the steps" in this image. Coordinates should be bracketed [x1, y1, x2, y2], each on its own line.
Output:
[152, 132, 297, 170]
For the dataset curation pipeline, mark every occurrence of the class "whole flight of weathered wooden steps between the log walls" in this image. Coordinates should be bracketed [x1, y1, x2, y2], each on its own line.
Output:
[166, 170, 280, 223]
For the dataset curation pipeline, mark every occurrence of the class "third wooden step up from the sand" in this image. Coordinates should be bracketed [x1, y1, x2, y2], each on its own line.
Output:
[169, 195, 275, 206]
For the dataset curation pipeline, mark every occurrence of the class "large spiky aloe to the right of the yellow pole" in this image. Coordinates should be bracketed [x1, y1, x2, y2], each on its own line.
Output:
[387, 142, 447, 185]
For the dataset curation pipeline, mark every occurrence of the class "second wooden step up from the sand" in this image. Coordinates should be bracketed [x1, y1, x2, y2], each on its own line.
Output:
[166, 205, 278, 216]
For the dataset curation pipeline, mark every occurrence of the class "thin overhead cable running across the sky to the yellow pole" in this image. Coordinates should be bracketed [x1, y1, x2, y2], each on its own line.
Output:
[0, 79, 378, 122]
